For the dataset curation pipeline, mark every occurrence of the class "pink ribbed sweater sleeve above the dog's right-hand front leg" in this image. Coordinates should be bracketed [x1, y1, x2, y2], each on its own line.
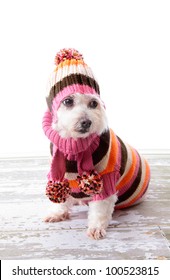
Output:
[92, 171, 120, 201]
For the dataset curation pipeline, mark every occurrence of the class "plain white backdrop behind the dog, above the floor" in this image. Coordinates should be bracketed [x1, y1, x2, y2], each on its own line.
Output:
[0, 0, 170, 156]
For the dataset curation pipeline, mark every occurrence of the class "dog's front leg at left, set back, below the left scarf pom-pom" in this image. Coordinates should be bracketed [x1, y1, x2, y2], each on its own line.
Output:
[44, 197, 72, 223]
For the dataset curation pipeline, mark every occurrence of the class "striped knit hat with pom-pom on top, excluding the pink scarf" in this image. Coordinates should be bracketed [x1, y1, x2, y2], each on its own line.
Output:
[47, 49, 100, 116]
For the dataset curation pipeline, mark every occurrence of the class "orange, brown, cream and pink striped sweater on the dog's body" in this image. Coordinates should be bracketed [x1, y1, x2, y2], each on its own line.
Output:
[50, 130, 150, 209]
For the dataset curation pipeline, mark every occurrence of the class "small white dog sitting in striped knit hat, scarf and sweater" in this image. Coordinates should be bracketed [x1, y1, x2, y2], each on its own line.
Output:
[43, 49, 150, 240]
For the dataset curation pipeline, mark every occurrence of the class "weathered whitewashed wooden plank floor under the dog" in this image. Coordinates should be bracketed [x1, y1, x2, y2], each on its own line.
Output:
[0, 155, 170, 260]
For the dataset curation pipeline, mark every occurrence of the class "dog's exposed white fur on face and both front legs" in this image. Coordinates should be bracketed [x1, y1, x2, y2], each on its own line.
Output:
[45, 93, 117, 239]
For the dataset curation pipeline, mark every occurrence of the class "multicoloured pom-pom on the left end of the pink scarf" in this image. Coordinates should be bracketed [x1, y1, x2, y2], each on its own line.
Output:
[46, 179, 71, 203]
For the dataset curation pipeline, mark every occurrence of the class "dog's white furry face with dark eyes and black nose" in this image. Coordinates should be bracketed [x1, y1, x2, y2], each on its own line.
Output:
[53, 93, 108, 138]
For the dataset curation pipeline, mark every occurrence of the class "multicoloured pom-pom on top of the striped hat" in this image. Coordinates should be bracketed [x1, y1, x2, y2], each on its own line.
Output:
[55, 49, 83, 66]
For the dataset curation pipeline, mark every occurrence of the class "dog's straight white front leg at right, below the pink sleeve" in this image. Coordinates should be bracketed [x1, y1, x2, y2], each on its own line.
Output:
[87, 195, 117, 239]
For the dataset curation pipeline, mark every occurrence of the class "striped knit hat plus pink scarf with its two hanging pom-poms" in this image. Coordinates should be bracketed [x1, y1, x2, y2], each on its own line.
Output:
[43, 49, 103, 203]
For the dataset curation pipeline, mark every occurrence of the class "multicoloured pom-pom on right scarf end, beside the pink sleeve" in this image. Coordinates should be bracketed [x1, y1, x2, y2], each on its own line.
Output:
[77, 170, 103, 195]
